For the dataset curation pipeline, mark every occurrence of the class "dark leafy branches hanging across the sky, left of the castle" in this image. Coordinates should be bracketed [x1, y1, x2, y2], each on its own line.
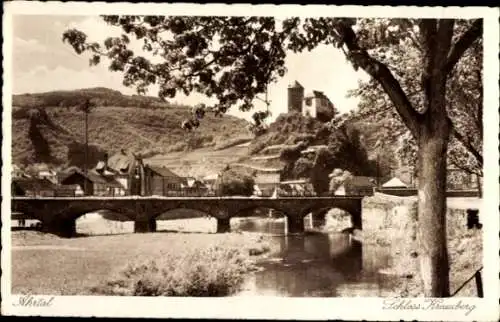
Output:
[63, 16, 297, 122]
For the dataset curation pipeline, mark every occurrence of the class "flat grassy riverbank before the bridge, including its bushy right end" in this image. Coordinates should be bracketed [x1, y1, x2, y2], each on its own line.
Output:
[12, 231, 269, 296]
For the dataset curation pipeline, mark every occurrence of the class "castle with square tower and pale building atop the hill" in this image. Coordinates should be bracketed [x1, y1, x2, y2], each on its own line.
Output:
[288, 81, 335, 122]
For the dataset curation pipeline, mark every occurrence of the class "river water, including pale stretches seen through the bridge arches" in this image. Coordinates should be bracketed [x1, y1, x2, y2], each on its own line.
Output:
[27, 214, 398, 297]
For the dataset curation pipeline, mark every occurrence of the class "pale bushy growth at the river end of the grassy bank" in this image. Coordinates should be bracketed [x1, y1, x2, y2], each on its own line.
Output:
[92, 246, 253, 297]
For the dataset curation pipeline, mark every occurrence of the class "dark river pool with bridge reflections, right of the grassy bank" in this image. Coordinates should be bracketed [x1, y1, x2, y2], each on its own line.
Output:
[232, 218, 394, 297]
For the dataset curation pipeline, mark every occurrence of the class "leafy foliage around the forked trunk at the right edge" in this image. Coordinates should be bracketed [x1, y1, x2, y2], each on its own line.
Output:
[350, 21, 483, 175]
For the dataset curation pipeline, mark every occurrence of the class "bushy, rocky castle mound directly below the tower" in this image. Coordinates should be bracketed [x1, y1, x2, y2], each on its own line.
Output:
[238, 112, 397, 178]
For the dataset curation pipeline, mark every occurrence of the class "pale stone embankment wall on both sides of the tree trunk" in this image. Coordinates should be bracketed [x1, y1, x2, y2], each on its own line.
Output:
[355, 194, 482, 297]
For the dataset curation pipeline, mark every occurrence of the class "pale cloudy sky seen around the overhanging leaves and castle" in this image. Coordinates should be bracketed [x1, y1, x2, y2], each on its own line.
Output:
[12, 15, 367, 121]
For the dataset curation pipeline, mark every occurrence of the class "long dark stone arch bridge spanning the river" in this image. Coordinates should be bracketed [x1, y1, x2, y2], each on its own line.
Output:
[11, 196, 362, 237]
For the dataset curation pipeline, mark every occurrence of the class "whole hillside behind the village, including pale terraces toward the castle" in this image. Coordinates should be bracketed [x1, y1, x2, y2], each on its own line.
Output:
[12, 88, 402, 180]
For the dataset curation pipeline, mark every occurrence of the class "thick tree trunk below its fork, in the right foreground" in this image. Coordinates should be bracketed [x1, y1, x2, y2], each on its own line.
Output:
[418, 122, 450, 297]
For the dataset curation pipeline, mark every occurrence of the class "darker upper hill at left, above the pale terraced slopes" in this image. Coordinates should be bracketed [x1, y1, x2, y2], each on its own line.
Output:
[12, 89, 251, 170]
